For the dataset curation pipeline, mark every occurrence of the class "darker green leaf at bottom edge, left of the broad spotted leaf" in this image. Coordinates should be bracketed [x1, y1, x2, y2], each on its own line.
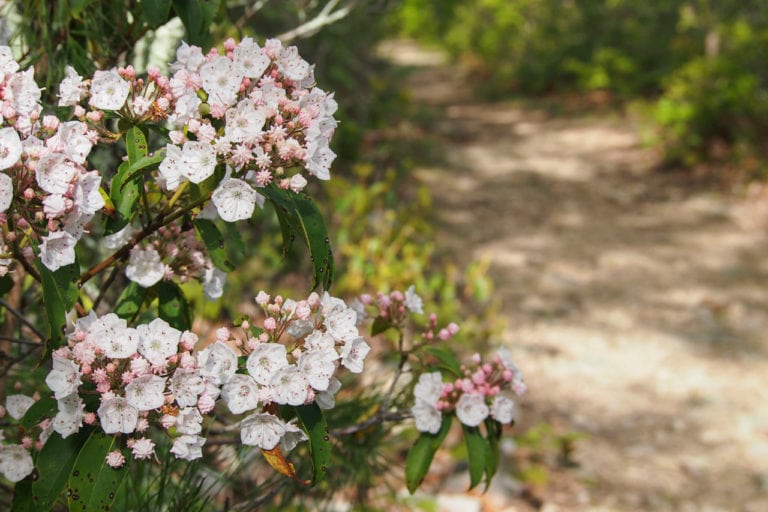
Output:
[31, 429, 89, 510]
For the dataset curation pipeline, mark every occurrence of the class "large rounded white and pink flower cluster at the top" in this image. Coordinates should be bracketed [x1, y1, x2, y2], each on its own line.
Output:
[160, 38, 337, 222]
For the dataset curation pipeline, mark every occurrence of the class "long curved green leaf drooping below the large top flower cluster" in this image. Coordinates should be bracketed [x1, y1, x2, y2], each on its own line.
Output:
[258, 184, 334, 290]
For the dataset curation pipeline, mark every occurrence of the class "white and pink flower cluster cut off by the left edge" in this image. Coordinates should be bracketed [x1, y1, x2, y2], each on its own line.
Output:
[0, 46, 104, 270]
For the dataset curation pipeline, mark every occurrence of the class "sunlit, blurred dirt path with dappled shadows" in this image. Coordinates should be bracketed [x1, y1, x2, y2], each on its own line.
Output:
[385, 43, 768, 512]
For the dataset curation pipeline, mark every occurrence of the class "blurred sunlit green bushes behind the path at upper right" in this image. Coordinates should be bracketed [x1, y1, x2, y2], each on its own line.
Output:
[393, 0, 768, 170]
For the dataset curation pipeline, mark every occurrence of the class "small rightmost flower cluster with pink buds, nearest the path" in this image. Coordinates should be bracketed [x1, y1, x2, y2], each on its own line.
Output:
[411, 349, 526, 434]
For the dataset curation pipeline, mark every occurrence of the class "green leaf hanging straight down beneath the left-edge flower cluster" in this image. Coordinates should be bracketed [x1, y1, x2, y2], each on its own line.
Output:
[37, 260, 80, 350]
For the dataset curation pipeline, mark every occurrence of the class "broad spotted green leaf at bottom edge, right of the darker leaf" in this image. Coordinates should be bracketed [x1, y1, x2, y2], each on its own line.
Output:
[67, 432, 128, 512]
